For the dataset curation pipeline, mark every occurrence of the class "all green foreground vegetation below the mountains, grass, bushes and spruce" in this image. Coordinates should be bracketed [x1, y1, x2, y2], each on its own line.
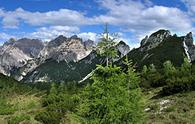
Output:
[0, 58, 195, 124]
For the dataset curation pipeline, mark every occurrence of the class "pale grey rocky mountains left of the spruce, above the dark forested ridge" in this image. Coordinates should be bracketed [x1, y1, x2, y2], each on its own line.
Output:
[0, 35, 99, 80]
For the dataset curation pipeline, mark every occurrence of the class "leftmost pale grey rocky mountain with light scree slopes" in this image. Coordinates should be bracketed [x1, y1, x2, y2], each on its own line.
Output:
[0, 38, 44, 75]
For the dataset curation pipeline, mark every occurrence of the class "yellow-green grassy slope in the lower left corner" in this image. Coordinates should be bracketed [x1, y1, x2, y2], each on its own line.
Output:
[0, 74, 41, 124]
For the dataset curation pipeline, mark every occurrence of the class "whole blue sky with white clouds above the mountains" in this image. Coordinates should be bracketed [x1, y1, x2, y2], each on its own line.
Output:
[0, 0, 195, 47]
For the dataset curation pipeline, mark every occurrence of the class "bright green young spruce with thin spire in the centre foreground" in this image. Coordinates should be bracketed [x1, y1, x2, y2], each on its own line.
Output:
[76, 24, 144, 124]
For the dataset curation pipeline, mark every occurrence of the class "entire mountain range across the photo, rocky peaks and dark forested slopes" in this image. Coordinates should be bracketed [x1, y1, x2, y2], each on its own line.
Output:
[0, 29, 195, 82]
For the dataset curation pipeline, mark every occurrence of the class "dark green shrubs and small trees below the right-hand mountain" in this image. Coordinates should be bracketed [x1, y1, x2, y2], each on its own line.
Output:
[141, 58, 195, 95]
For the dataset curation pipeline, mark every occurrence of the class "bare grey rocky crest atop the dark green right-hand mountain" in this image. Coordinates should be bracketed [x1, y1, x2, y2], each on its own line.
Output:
[141, 30, 171, 51]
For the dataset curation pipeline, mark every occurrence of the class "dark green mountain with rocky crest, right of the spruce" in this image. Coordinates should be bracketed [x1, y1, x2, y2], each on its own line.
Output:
[118, 30, 195, 69]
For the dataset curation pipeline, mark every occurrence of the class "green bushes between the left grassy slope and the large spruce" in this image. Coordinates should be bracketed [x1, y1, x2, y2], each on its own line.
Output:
[35, 84, 78, 124]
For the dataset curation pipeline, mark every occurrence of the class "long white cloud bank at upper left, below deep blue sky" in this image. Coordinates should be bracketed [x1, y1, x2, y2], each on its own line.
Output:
[0, 8, 91, 28]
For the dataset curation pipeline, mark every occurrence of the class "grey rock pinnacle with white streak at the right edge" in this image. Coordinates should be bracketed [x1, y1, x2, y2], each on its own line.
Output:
[183, 32, 195, 62]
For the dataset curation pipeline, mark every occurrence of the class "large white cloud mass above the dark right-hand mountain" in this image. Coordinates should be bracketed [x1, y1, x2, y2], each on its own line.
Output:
[95, 0, 194, 40]
